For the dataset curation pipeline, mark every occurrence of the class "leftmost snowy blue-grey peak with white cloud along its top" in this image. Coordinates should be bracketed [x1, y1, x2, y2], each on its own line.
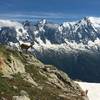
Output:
[0, 20, 28, 44]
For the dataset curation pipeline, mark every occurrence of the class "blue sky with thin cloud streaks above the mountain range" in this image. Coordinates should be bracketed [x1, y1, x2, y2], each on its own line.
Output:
[0, 0, 100, 22]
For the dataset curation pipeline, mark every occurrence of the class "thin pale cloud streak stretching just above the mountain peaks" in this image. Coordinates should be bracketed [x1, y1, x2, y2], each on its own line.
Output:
[0, 12, 90, 21]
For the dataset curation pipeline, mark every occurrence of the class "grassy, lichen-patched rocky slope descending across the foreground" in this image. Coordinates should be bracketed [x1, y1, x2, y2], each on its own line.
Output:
[0, 45, 88, 100]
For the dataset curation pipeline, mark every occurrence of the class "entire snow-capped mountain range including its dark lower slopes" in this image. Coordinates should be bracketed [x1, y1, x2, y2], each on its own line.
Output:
[0, 17, 100, 81]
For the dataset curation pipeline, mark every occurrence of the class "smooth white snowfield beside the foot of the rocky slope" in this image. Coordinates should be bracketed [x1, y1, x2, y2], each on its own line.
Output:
[76, 82, 100, 100]
